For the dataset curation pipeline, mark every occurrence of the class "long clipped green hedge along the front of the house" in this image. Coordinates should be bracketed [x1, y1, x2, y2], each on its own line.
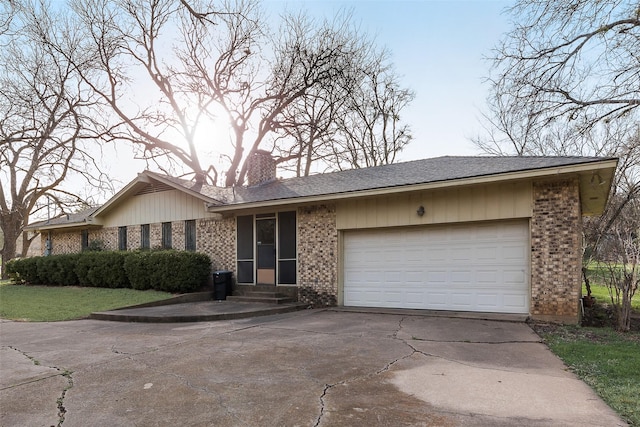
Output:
[7, 250, 211, 293]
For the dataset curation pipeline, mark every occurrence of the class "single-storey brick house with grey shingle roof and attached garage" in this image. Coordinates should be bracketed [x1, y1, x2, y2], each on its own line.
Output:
[29, 152, 617, 322]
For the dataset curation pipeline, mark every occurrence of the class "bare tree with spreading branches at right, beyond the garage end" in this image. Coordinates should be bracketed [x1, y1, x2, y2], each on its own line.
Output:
[475, 0, 640, 332]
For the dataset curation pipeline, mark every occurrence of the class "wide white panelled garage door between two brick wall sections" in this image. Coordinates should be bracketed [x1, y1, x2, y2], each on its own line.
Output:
[343, 221, 529, 313]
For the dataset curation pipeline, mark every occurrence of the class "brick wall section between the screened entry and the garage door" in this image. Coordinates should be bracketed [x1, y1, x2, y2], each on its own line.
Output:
[298, 204, 338, 306]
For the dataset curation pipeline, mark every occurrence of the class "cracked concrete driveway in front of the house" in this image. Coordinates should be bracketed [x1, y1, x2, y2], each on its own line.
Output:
[0, 310, 625, 427]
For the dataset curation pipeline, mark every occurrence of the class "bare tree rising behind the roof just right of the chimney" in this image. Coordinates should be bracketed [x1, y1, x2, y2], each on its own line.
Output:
[274, 15, 414, 176]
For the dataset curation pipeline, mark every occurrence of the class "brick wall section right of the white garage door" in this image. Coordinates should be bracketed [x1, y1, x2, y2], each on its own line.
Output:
[531, 179, 582, 322]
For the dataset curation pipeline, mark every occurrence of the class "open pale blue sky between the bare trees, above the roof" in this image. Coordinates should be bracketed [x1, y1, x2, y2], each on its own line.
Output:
[104, 0, 513, 185]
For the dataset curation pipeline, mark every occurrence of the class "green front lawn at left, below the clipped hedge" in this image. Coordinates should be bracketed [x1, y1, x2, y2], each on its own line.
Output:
[0, 281, 171, 322]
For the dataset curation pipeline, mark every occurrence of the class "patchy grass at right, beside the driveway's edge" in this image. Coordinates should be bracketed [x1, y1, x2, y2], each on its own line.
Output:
[536, 325, 640, 426]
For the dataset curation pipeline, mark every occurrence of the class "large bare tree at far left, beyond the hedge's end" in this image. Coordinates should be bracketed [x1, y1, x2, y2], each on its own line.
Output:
[0, 2, 110, 273]
